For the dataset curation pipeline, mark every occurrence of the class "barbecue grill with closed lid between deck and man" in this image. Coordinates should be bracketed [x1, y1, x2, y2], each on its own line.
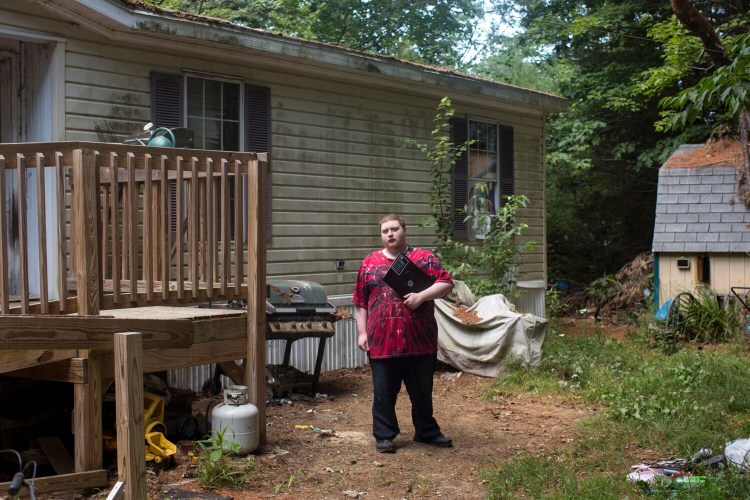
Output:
[266, 280, 339, 392]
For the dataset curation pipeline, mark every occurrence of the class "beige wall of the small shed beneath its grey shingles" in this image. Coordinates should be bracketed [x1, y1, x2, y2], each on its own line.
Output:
[659, 253, 750, 304]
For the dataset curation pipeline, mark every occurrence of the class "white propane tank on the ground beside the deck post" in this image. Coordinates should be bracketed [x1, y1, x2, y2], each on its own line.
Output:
[211, 385, 259, 455]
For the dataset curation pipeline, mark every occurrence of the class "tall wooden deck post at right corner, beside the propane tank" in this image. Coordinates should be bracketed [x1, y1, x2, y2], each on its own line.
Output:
[245, 153, 268, 445]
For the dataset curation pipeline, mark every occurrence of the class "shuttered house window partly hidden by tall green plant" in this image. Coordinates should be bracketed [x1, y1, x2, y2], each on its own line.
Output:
[451, 117, 515, 240]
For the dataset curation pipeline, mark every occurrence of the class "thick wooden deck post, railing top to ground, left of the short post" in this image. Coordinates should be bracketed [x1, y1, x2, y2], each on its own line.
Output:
[71, 148, 104, 472]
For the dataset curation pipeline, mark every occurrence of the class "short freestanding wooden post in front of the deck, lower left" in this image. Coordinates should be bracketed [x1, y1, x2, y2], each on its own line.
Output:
[115, 332, 146, 500]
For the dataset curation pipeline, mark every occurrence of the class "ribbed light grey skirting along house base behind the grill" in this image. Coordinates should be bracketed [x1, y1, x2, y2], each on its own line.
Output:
[168, 295, 367, 392]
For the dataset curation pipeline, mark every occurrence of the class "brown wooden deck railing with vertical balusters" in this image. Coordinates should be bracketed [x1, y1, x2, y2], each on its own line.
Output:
[0, 142, 266, 314]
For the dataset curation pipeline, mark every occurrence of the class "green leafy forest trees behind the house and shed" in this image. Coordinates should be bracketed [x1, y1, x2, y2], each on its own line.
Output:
[142, 0, 750, 287]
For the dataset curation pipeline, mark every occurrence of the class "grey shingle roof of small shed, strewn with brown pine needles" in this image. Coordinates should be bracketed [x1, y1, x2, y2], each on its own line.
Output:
[653, 144, 750, 253]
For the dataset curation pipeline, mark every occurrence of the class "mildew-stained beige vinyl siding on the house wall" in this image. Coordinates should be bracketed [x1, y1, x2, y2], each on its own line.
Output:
[0, 0, 545, 295]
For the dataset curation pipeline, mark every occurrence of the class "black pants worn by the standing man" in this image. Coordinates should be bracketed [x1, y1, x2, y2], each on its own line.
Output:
[370, 354, 440, 441]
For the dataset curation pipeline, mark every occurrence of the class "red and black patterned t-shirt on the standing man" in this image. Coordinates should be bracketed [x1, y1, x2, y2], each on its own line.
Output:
[352, 247, 453, 359]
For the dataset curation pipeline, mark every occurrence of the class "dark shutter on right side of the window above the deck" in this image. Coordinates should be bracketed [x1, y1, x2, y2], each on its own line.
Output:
[245, 85, 271, 239]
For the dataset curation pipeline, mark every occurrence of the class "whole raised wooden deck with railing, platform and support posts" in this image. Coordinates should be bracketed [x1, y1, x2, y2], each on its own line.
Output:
[0, 142, 267, 500]
